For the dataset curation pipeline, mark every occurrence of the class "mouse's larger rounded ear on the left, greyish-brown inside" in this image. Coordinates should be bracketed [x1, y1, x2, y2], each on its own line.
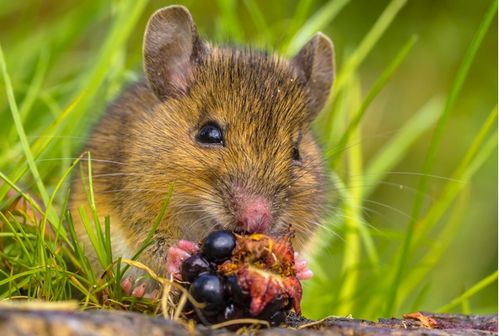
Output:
[144, 5, 208, 100]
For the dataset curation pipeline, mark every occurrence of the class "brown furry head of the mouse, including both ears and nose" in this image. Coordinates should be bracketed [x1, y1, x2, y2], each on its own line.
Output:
[137, 6, 334, 242]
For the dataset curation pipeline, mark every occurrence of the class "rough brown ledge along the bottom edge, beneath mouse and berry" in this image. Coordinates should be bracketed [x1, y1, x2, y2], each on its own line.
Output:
[0, 303, 498, 336]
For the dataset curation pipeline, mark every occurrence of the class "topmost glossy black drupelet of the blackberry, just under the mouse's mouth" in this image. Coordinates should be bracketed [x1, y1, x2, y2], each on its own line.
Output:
[201, 231, 236, 263]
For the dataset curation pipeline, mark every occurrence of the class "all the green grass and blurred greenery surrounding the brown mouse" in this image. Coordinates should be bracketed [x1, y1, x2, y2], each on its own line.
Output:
[0, 0, 497, 319]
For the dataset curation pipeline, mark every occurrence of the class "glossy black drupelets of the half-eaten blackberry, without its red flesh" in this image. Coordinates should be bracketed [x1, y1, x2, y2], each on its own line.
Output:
[181, 231, 291, 326]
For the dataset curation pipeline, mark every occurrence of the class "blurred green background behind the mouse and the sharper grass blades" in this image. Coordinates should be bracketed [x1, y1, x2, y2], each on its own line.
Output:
[0, 0, 498, 318]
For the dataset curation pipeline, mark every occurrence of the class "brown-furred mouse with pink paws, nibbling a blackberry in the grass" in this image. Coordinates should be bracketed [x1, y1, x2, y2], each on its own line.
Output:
[70, 5, 335, 297]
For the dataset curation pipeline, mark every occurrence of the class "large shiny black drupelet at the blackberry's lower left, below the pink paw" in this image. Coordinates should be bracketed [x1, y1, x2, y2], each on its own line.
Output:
[189, 274, 226, 314]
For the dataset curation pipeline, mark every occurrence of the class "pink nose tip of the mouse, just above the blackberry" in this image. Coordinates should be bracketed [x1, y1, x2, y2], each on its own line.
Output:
[239, 197, 272, 233]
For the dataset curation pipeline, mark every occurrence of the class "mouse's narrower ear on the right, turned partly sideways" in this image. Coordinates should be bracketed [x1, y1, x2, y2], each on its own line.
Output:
[291, 33, 335, 118]
